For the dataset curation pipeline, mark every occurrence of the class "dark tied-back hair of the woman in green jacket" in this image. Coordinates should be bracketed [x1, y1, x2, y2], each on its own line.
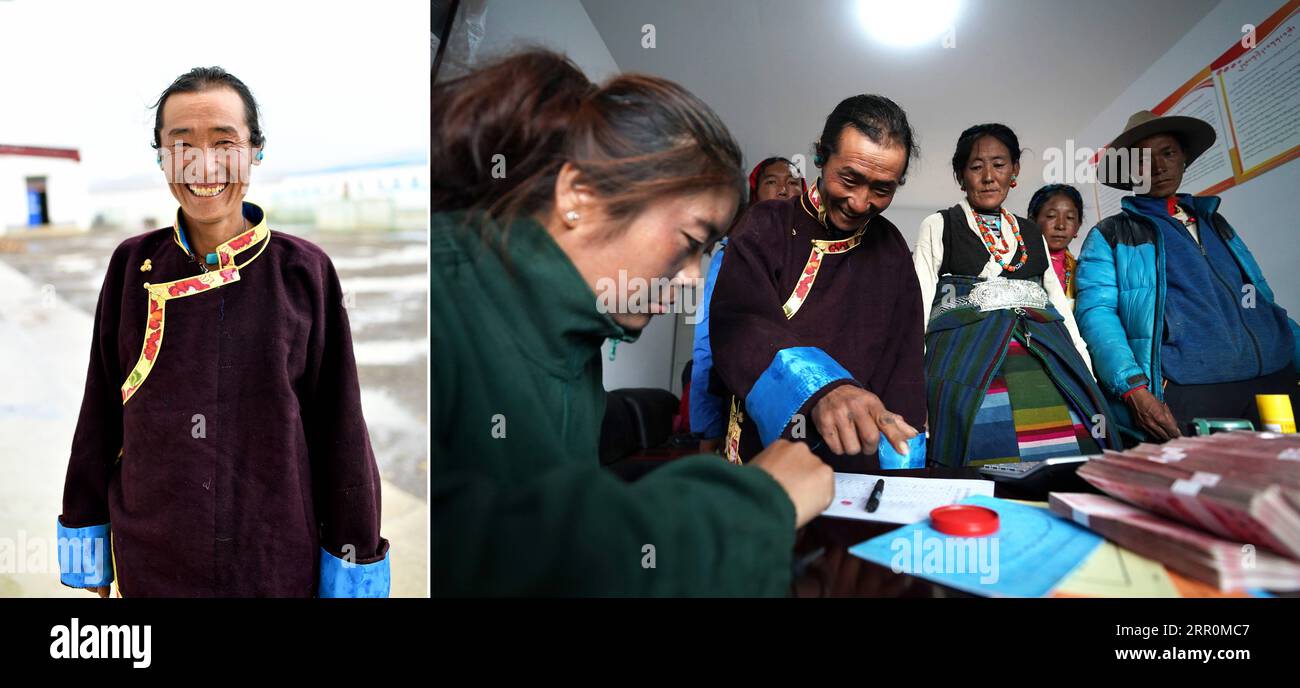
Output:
[430, 49, 745, 234]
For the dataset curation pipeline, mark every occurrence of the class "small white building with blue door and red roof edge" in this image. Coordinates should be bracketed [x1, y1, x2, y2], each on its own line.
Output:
[0, 143, 91, 234]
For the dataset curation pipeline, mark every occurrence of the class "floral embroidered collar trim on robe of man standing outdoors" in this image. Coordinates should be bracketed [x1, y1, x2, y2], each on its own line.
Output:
[122, 204, 270, 404]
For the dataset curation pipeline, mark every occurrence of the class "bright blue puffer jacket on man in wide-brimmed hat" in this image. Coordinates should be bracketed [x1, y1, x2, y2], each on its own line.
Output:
[1074, 196, 1300, 440]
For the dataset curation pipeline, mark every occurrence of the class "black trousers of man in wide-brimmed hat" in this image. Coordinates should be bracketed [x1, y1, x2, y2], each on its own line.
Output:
[1165, 363, 1300, 434]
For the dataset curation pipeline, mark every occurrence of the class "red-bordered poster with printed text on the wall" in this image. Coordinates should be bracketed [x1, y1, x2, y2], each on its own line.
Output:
[1093, 0, 1300, 217]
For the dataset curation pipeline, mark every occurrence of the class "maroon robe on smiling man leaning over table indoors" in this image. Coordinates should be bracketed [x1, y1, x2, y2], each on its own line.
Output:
[709, 182, 926, 472]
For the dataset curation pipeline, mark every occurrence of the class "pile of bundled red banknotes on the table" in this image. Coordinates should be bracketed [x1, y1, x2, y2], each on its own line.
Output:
[1050, 432, 1300, 590]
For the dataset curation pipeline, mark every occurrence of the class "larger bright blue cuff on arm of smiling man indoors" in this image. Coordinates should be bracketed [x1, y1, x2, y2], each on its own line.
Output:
[745, 346, 853, 446]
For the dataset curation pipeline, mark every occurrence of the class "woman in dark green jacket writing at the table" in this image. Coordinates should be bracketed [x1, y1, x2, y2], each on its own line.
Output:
[430, 51, 833, 596]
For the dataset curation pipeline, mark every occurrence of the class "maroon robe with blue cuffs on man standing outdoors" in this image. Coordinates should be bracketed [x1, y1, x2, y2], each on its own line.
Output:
[59, 203, 389, 597]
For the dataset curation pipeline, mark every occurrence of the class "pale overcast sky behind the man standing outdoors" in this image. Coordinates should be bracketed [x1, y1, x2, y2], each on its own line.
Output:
[0, 0, 429, 186]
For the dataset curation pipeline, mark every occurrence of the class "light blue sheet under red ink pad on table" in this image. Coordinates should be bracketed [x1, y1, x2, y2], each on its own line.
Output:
[849, 496, 1102, 597]
